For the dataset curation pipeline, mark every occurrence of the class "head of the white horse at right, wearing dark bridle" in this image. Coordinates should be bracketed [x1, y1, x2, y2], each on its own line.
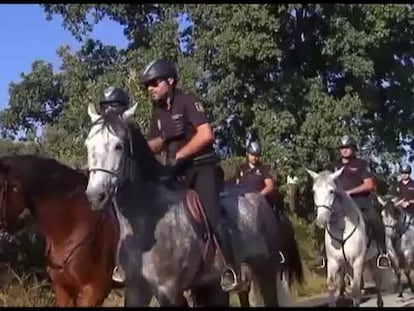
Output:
[306, 168, 343, 228]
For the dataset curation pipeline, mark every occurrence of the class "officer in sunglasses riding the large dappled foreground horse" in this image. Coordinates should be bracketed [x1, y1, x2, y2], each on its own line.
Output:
[140, 59, 244, 291]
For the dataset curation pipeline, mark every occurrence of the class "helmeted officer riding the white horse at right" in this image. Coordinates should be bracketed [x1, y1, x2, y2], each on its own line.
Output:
[321, 135, 391, 269]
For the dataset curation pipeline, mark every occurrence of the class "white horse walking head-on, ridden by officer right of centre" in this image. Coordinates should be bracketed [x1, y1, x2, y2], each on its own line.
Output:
[306, 168, 385, 307]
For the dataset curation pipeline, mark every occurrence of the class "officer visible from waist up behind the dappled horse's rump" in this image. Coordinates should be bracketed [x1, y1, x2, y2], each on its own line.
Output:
[236, 141, 275, 211]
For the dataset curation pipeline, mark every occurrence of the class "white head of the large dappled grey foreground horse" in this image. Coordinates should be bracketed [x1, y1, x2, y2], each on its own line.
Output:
[85, 103, 138, 210]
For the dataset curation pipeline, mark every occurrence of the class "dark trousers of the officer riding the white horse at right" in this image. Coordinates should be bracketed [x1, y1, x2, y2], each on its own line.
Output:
[320, 197, 386, 254]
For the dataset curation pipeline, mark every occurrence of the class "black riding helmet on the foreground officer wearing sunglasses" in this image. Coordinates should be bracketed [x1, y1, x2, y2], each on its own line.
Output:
[139, 59, 178, 85]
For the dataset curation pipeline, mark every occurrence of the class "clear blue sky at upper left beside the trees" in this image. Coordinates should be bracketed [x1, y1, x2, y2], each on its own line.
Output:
[0, 4, 127, 110]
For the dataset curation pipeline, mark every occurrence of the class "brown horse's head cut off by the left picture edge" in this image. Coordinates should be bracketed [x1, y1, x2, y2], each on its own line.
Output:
[0, 160, 30, 246]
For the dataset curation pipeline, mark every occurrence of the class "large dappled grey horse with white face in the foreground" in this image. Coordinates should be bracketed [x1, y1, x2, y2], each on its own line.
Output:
[85, 104, 298, 306]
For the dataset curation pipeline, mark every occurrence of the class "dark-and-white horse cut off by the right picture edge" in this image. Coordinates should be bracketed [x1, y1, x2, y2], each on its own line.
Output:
[377, 195, 414, 298]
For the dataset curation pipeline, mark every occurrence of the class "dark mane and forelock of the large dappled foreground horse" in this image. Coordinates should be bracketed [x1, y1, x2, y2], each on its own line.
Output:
[102, 110, 164, 181]
